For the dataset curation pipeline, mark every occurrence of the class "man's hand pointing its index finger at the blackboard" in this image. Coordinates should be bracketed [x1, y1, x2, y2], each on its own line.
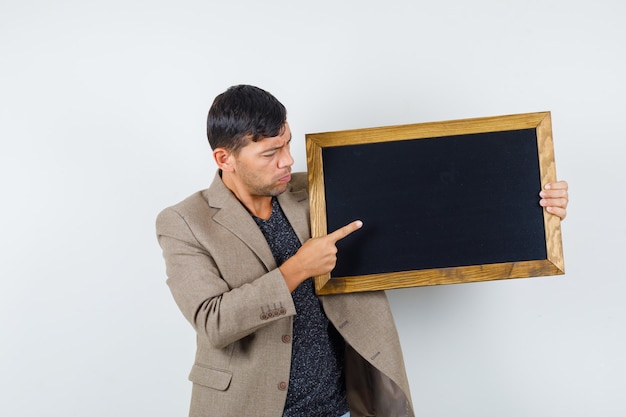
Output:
[279, 220, 363, 291]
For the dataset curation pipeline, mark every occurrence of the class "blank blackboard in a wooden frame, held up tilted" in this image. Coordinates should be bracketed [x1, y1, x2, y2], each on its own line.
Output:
[306, 112, 564, 295]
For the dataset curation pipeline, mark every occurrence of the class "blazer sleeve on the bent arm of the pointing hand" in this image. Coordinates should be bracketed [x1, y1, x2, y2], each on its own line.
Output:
[156, 207, 296, 348]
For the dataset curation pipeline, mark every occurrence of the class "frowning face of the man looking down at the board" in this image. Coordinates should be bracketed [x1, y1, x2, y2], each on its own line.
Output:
[232, 123, 294, 197]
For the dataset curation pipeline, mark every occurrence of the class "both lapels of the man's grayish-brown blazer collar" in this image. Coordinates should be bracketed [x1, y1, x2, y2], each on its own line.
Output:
[203, 170, 310, 271]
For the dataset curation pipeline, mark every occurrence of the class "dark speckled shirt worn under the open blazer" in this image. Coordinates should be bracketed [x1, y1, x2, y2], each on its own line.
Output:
[253, 198, 348, 417]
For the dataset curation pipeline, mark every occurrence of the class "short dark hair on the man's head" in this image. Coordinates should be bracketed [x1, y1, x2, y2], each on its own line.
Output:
[207, 85, 287, 153]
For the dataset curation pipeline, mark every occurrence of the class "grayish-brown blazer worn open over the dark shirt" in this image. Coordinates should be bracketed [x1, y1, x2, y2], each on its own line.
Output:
[157, 173, 414, 417]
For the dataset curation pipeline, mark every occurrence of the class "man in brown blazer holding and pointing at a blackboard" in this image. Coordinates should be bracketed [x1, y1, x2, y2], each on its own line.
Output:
[157, 85, 567, 417]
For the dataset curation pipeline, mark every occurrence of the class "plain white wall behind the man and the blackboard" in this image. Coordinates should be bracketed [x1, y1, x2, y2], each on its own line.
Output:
[0, 0, 626, 417]
